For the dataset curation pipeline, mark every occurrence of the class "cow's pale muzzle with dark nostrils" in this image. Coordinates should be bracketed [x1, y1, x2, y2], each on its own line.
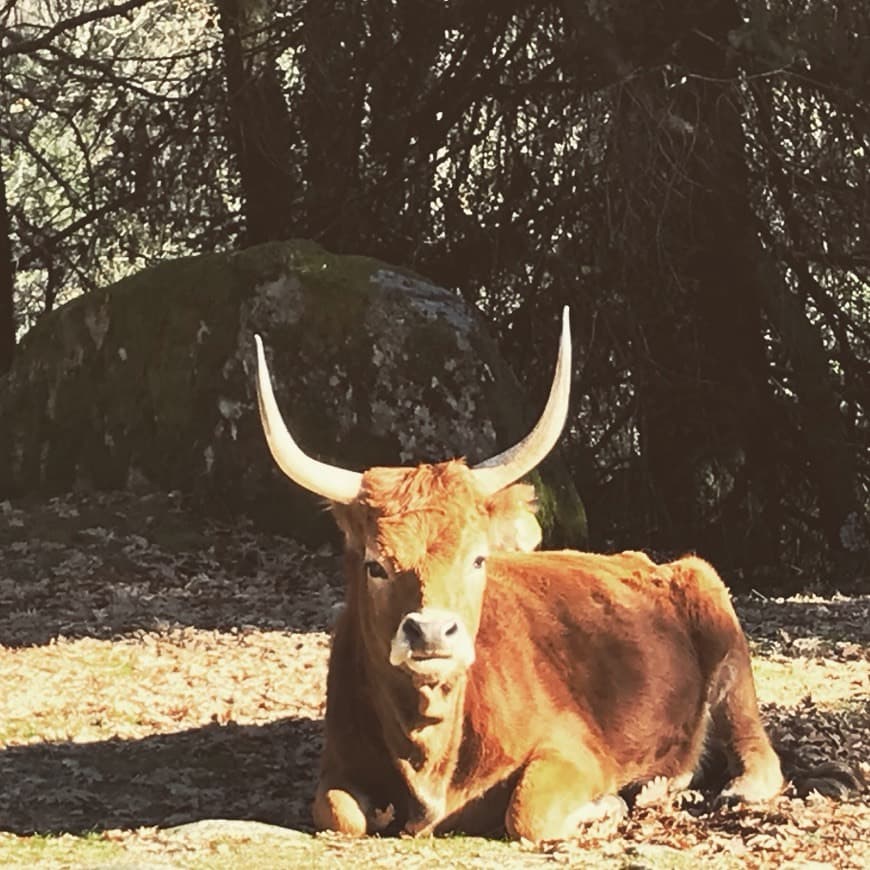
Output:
[390, 607, 474, 677]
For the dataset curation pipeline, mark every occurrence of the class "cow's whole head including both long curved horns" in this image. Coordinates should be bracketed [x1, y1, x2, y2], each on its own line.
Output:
[256, 308, 571, 684]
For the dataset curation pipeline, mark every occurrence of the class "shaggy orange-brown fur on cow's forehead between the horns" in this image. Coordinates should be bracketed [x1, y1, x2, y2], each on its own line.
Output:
[361, 460, 487, 571]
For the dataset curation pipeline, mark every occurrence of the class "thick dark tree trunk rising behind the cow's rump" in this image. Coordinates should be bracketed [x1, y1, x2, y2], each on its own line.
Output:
[600, 0, 782, 564]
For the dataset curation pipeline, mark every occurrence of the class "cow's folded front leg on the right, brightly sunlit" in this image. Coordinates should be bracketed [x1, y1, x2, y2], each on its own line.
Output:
[505, 752, 624, 843]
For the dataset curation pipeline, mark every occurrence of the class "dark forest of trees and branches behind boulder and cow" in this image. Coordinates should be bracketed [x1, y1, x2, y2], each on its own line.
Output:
[0, 0, 870, 584]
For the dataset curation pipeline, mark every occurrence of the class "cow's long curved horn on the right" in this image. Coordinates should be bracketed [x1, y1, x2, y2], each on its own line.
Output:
[472, 305, 571, 495]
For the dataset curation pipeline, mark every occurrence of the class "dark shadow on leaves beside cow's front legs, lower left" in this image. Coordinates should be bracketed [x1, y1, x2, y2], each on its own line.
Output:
[0, 718, 322, 834]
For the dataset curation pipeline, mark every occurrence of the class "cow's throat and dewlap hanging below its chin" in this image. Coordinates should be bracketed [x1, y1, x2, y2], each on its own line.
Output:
[362, 664, 467, 834]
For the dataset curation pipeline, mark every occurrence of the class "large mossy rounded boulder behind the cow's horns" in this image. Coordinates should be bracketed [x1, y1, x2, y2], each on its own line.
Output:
[0, 241, 585, 545]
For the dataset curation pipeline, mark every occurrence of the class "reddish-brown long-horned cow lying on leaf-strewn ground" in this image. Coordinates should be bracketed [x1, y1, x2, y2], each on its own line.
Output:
[257, 310, 782, 842]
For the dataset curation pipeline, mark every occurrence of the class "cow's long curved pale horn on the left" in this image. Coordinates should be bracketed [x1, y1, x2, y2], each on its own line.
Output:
[254, 335, 362, 504]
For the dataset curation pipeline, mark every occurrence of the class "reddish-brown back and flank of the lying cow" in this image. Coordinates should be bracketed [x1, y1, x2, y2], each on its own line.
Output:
[466, 551, 712, 784]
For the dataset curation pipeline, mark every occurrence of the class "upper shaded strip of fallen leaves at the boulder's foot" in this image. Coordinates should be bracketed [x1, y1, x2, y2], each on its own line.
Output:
[0, 492, 343, 647]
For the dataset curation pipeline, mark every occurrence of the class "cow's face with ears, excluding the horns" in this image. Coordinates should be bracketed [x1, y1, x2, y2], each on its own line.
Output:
[334, 462, 540, 683]
